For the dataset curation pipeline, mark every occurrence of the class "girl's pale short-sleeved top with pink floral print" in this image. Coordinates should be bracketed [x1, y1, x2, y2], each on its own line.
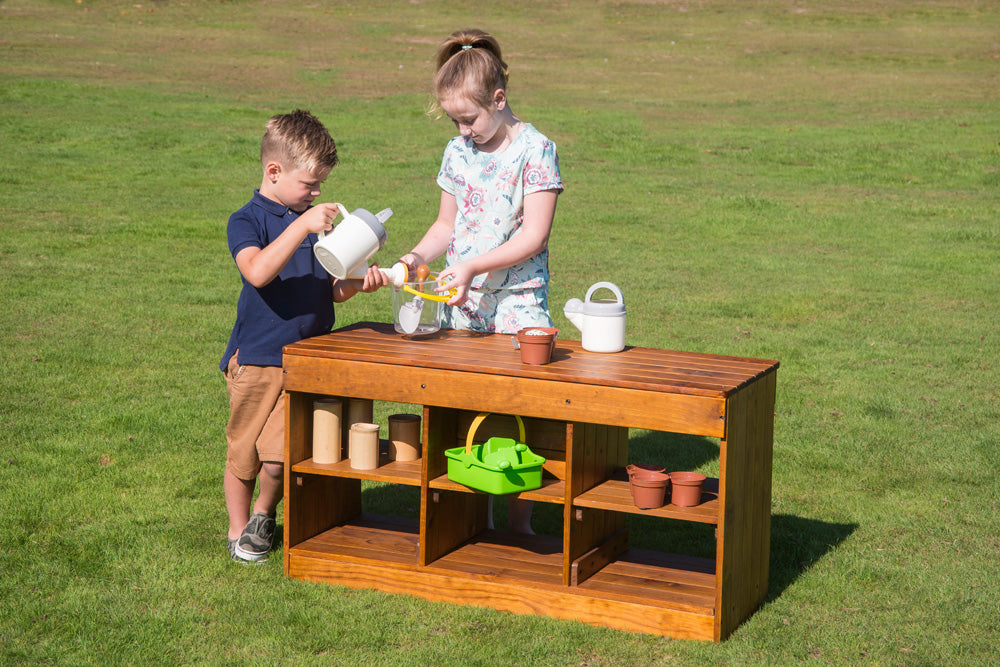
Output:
[437, 123, 563, 292]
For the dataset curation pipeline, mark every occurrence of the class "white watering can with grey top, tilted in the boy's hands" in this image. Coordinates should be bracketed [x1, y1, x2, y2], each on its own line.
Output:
[313, 204, 406, 285]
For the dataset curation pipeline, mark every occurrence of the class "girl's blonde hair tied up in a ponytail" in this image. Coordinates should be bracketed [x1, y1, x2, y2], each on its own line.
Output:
[432, 28, 509, 112]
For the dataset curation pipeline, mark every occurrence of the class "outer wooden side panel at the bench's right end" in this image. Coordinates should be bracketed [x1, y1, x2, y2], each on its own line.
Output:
[715, 372, 777, 640]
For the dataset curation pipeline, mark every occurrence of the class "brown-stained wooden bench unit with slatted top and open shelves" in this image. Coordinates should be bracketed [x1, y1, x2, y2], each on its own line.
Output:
[284, 323, 778, 641]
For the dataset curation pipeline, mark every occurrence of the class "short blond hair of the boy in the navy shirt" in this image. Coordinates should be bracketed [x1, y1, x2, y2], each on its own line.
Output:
[260, 109, 339, 174]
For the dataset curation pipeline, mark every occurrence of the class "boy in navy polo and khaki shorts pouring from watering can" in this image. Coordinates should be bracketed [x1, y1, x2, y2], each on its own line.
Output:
[219, 110, 388, 562]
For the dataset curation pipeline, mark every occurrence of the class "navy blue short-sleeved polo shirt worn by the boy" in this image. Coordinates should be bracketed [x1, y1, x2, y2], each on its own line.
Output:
[219, 190, 334, 371]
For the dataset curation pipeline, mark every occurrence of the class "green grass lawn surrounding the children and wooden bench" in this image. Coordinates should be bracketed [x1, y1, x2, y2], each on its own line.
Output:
[0, 0, 1000, 666]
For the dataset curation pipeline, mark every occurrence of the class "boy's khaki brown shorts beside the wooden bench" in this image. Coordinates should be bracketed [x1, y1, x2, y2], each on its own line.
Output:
[224, 352, 285, 480]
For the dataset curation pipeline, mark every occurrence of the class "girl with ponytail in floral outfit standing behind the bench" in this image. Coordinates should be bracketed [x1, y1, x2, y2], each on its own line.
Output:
[401, 30, 563, 333]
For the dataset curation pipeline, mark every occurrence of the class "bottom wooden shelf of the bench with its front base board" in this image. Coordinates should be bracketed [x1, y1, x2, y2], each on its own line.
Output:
[285, 514, 716, 640]
